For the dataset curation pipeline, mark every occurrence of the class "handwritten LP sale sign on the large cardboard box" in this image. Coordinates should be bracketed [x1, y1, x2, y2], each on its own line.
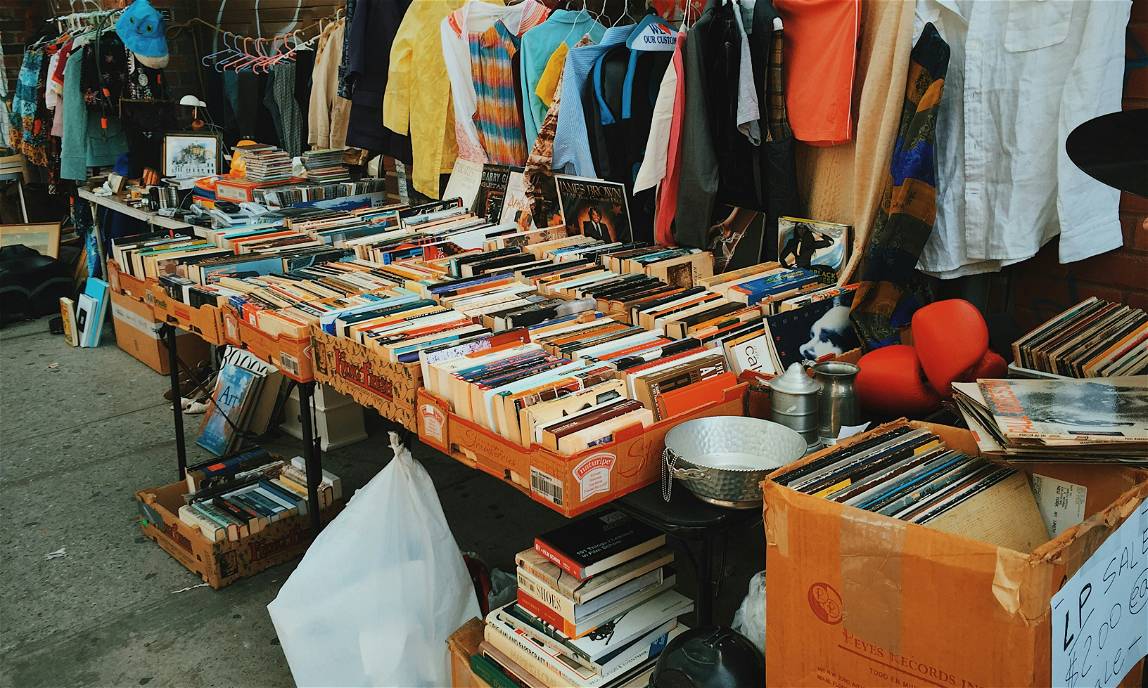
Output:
[1052, 500, 1148, 688]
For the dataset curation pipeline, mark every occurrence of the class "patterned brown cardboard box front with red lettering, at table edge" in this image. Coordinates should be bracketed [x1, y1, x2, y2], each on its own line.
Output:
[311, 326, 422, 431]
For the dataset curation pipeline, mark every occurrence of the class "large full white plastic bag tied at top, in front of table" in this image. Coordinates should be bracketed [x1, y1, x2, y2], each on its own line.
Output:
[267, 432, 479, 687]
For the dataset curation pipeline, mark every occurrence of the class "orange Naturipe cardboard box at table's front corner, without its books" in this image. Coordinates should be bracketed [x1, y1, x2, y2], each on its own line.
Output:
[417, 384, 746, 518]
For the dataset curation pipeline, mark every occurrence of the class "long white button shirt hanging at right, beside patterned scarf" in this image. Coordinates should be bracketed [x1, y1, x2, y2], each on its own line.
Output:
[914, 0, 1132, 278]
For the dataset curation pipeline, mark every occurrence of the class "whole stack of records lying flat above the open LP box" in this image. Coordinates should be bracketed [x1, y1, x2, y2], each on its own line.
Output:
[953, 376, 1148, 464]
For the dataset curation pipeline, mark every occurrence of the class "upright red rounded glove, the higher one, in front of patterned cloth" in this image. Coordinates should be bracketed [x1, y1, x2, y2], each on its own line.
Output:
[913, 299, 988, 399]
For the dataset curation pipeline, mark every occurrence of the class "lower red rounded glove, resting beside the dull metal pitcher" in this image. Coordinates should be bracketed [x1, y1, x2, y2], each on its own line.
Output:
[854, 345, 940, 418]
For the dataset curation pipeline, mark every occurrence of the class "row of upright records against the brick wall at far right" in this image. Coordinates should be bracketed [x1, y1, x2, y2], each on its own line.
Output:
[1009, 296, 1148, 378]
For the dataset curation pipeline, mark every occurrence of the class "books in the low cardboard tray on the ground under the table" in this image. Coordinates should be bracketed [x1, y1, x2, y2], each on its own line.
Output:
[179, 448, 342, 542]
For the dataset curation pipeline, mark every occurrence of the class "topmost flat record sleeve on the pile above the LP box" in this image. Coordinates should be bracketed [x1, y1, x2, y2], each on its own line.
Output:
[977, 376, 1148, 446]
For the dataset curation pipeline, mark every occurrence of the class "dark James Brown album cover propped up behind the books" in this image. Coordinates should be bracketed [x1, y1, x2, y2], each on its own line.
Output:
[554, 175, 634, 243]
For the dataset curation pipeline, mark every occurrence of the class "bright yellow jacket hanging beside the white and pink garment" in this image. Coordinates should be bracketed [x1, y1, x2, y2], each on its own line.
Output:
[382, 0, 502, 199]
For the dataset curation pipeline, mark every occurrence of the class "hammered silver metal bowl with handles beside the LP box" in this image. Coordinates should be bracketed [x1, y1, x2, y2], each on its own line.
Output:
[661, 416, 806, 509]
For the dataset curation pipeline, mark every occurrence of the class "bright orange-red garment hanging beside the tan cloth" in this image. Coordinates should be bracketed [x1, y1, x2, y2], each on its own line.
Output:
[774, 0, 861, 146]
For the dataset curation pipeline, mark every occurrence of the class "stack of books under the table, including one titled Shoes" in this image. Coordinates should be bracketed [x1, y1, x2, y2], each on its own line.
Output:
[480, 511, 693, 688]
